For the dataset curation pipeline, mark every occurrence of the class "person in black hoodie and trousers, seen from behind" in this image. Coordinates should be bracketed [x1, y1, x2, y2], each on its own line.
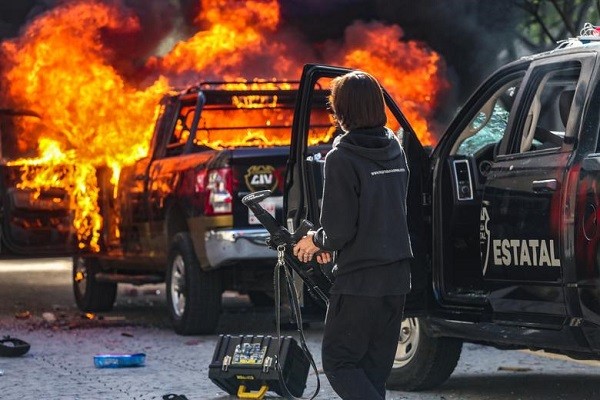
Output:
[294, 71, 413, 400]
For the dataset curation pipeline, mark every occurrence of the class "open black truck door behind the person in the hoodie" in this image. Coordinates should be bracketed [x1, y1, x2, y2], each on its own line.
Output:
[284, 64, 433, 316]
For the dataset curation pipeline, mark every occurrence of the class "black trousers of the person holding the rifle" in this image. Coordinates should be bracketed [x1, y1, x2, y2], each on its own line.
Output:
[321, 294, 406, 400]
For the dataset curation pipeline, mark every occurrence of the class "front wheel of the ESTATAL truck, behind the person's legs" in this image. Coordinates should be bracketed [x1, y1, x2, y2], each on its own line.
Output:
[387, 318, 462, 391]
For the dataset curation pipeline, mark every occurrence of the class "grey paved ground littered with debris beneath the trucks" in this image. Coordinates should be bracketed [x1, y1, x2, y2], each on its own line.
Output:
[0, 260, 600, 400]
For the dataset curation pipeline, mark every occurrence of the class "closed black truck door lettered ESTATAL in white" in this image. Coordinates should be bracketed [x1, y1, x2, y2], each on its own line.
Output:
[481, 54, 595, 329]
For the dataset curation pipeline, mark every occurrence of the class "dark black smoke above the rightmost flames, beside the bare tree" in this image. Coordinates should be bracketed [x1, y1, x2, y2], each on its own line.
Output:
[282, 0, 522, 121]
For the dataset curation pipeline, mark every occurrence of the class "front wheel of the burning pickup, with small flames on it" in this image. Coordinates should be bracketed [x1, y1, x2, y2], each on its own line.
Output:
[72, 257, 117, 312]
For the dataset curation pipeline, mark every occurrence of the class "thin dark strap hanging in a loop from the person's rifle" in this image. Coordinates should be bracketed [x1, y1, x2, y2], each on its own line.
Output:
[273, 245, 321, 400]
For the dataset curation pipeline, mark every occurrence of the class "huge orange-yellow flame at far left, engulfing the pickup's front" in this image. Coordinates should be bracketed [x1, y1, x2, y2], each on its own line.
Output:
[1, 1, 168, 250]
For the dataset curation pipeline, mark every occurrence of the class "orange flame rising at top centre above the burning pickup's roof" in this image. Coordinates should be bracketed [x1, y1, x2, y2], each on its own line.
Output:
[148, 0, 302, 83]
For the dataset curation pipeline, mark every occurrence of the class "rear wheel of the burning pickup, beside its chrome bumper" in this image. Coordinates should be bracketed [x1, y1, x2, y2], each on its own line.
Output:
[167, 232, 222, 335]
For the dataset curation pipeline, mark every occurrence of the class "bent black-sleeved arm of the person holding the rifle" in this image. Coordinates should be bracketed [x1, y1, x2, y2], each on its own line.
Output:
[312, 151, 359, 251]
